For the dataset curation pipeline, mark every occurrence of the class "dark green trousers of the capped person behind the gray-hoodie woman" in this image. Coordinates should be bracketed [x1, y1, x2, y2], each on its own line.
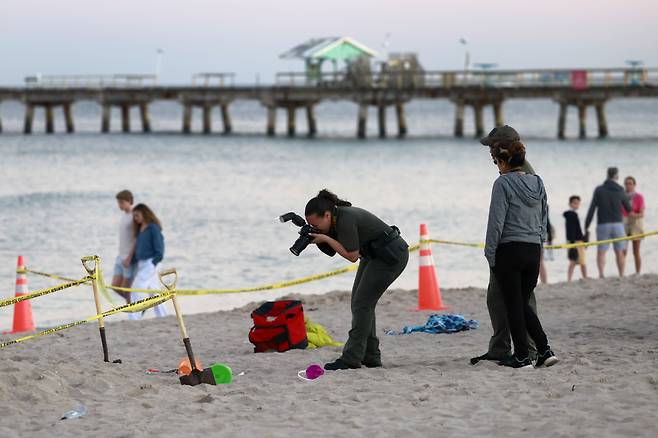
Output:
[487, 270, 537, 359]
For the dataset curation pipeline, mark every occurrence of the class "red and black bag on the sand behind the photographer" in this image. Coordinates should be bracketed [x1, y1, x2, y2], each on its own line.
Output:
[249, 300, 308, 353]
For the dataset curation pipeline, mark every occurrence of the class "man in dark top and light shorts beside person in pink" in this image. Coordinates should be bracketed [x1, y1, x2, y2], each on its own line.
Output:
[585, 167, 631, 278]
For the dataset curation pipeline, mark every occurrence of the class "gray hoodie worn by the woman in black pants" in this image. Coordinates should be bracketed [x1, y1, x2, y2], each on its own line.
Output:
[484, 172, 548, 268]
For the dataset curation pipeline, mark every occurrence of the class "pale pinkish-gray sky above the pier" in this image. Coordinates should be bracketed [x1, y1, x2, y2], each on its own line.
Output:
[0, 0, 658, 85]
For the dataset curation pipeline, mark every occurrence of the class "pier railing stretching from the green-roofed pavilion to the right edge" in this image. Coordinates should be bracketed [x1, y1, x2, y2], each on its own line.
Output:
[275, 68, 658, 89]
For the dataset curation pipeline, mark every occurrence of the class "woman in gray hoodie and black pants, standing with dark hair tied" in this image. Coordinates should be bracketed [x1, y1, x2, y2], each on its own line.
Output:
[484, 141, 558, 368]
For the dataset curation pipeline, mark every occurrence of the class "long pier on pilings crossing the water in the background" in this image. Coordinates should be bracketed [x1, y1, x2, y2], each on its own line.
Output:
[0, 68, 658, 139]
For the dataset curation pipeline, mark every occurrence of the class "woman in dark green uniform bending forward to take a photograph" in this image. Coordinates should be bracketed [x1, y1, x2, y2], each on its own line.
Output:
[304, 190, 409, 370]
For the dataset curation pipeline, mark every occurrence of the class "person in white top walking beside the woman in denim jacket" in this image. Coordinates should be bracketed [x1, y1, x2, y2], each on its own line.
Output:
[112, 190, 135, 303]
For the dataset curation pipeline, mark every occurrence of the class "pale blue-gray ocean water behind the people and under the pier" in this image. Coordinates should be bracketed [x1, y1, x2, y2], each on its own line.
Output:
[0, 100, 658, 329]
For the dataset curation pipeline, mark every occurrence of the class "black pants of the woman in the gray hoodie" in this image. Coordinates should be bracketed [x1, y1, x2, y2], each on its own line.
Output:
[494, 242, 548, 359]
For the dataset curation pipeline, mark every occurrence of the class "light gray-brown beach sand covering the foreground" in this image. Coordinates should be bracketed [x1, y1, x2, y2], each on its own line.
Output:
[0, 275, 658, 438]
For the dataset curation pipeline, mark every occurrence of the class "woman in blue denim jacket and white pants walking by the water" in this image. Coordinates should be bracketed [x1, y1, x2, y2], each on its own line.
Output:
[128, 204, 167, 319]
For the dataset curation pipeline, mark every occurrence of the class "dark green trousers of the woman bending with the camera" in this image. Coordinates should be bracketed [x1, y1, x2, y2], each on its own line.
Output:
[341, 243, 409, 366]
